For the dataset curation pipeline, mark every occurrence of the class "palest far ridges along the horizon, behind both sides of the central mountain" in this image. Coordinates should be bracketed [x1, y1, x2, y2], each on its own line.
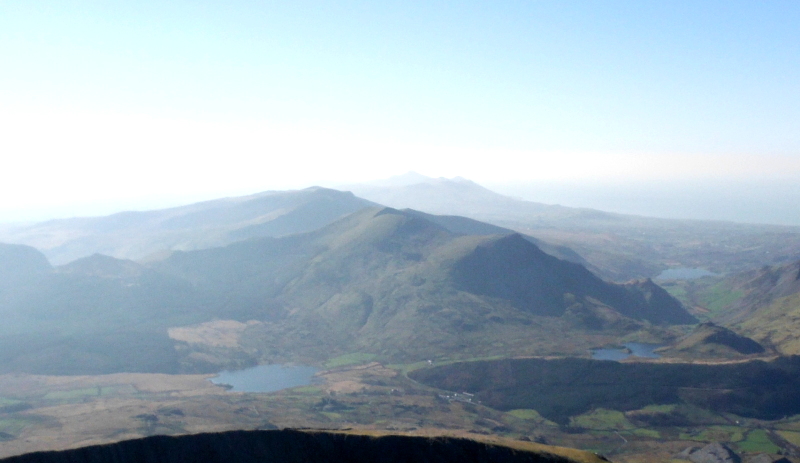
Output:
[0, 174, 800, 282]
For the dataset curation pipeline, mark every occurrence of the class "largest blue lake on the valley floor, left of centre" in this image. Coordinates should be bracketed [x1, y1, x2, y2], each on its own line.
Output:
[209, 365, 319, 392]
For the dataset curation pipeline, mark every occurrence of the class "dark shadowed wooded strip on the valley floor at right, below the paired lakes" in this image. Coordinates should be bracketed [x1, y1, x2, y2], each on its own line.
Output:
[409, 356, 800, 424]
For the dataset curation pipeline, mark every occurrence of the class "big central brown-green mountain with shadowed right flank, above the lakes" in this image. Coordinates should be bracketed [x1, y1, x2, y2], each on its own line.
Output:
[152, 208, 695, 368]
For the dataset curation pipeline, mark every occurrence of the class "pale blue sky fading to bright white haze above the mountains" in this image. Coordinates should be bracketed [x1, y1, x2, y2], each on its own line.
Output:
[0, 0, 800, 223]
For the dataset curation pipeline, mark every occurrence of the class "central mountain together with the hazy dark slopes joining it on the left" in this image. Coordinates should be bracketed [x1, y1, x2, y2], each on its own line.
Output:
[0, 208, 695, 374]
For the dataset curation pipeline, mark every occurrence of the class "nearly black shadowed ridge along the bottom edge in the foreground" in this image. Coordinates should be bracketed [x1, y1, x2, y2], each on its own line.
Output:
[0, 430, 601, 463]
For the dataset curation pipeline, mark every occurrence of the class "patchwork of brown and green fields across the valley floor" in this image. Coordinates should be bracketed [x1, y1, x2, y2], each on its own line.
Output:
[0, 362, 800, 462]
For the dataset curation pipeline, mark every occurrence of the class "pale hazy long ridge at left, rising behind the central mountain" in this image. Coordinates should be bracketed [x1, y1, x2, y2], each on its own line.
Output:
[0, 187, 374, 264]
